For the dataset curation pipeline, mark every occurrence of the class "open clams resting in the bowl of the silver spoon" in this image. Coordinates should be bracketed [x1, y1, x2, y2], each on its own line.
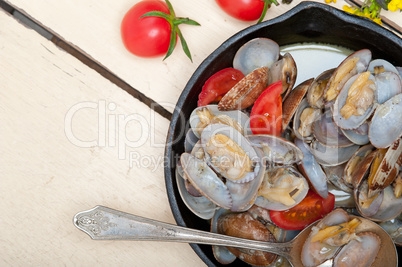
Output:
[302, 209, 386, 267]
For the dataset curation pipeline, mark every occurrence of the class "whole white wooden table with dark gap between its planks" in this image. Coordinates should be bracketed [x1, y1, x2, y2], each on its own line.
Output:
[0, 0, 402, 266]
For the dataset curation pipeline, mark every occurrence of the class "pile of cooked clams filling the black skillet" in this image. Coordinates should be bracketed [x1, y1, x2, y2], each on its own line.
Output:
[176, 38, 402, 266]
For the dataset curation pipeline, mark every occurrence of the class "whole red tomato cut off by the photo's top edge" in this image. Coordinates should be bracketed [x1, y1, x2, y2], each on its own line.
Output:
[215, 0, 278, 22]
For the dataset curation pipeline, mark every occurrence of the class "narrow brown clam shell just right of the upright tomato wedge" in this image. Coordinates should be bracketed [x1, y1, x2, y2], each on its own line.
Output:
[282, 79, 313, 131]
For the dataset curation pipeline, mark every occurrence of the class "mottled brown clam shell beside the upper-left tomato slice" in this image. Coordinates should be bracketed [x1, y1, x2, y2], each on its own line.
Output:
[218, 67, 268, 111]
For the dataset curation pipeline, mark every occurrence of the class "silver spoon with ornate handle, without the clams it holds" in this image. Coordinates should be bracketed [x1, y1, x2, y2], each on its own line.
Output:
[74, 206, 398, 267]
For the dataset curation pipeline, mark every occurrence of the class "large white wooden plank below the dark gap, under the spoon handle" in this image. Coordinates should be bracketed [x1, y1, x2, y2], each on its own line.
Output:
[0, 10, 204, 266]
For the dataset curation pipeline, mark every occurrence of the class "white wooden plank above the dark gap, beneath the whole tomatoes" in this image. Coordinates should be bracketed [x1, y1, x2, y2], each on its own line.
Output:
[7, 0, 402, 111]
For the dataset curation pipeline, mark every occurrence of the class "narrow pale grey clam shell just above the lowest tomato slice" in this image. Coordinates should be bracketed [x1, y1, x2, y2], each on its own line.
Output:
[295, 138, 328, 198]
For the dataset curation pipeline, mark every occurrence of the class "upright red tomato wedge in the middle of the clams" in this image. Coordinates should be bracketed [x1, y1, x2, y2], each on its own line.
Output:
[250, 81, 282, 136]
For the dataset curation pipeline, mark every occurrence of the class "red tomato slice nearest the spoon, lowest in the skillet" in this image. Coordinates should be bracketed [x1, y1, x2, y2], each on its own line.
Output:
[269, 190, 335, 230]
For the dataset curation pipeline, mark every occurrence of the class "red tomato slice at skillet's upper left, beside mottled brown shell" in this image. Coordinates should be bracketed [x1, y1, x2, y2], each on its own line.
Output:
[198, 68, 244, 107]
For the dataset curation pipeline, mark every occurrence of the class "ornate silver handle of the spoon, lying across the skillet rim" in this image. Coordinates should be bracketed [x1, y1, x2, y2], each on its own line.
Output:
[74, 206, 291, 257]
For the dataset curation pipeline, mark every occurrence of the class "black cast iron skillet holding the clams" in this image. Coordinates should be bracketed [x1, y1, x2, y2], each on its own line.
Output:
[165, 2, 402, 266]
